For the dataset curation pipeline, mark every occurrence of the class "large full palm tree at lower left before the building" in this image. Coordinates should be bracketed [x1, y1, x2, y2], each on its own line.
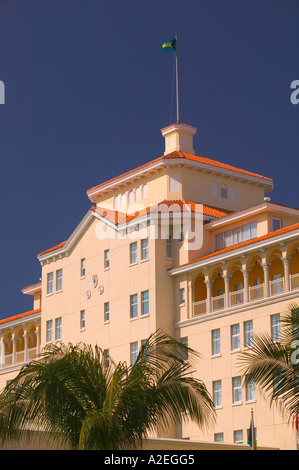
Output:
[2, 331, 215, 450]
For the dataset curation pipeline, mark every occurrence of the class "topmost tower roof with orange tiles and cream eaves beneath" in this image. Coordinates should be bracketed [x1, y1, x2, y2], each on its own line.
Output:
[87, 150, 273, 202]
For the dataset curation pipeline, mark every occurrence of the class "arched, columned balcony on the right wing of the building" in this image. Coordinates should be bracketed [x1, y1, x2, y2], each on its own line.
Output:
[191, 246, 299, 317]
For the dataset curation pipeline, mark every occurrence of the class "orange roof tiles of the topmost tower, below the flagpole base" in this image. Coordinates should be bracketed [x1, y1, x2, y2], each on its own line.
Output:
[87, 150, 273, 193]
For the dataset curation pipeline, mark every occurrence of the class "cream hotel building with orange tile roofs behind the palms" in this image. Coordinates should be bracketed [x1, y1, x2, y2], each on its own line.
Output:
[0, 124, 299, 449]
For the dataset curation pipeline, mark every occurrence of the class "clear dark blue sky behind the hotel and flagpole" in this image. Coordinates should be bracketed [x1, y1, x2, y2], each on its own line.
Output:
[0, 0, 299, 318]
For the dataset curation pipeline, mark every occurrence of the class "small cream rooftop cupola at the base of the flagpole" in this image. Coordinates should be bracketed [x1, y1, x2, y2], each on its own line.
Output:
[161, 122, 197, 155]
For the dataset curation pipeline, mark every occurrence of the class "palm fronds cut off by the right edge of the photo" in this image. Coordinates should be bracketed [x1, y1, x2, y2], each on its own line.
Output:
[240, 303, 299, 421]
